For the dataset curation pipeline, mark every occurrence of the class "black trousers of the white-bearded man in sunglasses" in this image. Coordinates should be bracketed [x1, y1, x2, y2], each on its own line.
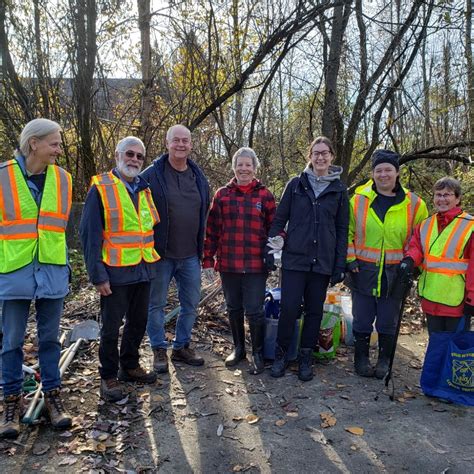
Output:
[99, 282, 150, 380]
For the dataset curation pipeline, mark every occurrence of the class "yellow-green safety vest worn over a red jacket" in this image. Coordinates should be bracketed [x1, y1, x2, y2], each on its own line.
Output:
[418, 212, 474, 306]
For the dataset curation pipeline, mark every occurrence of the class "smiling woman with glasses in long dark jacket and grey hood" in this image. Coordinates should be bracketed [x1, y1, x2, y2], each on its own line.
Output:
[266, 137, 349, 381]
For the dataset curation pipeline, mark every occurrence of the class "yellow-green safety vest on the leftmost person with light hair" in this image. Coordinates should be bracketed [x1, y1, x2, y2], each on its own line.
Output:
[0, 160, 72, 273]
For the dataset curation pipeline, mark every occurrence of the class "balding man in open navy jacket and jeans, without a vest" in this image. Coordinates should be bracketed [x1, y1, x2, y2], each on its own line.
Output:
[141, 125, 210, 373]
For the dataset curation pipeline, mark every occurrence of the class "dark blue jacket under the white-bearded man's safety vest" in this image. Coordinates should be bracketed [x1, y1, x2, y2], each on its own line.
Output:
[79, 169, 156, 286]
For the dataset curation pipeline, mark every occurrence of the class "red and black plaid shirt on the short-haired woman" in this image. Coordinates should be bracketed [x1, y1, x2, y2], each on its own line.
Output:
[203, 178, 276, 273]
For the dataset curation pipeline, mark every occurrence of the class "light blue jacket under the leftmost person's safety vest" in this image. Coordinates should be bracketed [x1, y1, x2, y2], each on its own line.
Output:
[0, 156, 71, 300]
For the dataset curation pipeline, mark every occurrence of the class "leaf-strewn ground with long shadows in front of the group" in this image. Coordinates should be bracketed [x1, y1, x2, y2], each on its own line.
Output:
[0, 324, 474, 473]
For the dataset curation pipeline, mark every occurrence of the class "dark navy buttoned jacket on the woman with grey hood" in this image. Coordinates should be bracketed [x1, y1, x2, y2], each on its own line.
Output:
[269, 173, 349, 275]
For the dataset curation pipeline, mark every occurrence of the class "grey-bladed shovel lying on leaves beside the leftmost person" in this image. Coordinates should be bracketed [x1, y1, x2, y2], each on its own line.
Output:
[22, 319, 99, 424]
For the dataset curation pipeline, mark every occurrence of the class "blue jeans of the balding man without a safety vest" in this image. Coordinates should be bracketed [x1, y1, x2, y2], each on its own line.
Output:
[146, 255, 201, 349]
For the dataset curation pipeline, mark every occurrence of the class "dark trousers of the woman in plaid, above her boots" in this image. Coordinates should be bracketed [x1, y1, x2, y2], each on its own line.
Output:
[221, 272, 267, 322]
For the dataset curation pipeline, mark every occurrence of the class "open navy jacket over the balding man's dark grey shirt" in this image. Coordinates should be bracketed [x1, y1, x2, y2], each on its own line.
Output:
[141, 153, 210, 258]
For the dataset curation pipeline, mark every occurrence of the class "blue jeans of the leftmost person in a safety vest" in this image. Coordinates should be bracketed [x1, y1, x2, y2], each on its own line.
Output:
[2, 298, 64, 396]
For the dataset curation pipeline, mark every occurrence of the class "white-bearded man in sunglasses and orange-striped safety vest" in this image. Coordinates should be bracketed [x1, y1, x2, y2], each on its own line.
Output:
[80, 137, 160, 401]
